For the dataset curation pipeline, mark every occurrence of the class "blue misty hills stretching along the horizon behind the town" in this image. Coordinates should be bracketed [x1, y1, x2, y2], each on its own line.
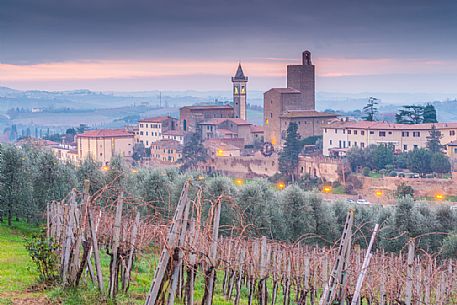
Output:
[0, 87, 457, 135]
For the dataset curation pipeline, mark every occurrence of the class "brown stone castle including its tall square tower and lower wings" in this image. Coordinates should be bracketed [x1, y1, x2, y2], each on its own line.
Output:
[263, 51, 337, 147]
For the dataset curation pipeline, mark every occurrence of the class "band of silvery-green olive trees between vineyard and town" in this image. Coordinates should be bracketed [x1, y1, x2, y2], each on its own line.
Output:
[0, 145, 457, 255]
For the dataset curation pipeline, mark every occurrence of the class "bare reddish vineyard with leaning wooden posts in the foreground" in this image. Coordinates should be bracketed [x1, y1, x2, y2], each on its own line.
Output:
[47, 180, 457, 305]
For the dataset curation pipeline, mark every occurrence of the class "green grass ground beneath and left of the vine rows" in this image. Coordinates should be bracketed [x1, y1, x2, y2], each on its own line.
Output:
[0, 222, 282, 305]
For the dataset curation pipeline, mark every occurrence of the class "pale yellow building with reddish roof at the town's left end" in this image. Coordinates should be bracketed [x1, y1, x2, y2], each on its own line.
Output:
[76, 129, 134, 164]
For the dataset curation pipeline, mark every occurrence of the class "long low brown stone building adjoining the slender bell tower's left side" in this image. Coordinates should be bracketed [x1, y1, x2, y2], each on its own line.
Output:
[179, 105, 234, 132]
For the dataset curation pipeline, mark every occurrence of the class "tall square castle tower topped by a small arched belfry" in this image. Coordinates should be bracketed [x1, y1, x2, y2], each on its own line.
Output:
[287, 51, 315, 110]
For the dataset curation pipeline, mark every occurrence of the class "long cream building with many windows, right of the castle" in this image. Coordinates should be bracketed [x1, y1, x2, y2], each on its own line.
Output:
[323, 121, 457, 156]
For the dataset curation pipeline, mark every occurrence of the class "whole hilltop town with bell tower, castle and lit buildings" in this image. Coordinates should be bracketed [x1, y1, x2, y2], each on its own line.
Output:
[9, 51, 457, 201]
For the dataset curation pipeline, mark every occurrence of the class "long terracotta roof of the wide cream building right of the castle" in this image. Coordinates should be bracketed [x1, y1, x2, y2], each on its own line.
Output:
[327, 121, 457, 130]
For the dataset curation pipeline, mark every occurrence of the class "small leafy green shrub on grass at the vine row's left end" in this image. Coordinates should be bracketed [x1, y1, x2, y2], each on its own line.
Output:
[25, 230, 59, 283]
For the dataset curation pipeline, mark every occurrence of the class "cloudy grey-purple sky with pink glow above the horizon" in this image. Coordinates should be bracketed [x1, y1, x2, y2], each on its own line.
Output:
[0, 0, 457, 94]
